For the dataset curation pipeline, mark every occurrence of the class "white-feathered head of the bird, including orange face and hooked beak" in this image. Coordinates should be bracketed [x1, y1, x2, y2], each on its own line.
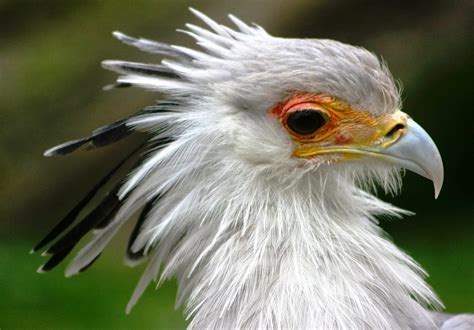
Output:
[110, 10, 443, 197]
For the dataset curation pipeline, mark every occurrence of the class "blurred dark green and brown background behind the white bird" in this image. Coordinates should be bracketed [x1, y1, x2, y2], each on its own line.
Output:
[0, 0, 474, 329]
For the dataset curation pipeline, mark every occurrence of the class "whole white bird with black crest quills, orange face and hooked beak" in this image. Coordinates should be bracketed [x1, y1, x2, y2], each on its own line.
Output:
[33, 10, 474, 329]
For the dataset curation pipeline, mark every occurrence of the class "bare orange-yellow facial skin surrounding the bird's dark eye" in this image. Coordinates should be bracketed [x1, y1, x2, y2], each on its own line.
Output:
[270, 93, 408, 158]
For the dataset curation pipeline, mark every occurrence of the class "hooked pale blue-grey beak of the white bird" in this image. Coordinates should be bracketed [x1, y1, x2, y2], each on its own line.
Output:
[379, 118, 444, 198]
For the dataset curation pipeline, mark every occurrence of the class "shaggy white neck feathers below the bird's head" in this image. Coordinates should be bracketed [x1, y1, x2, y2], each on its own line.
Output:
[163, 169, 438, 329]
